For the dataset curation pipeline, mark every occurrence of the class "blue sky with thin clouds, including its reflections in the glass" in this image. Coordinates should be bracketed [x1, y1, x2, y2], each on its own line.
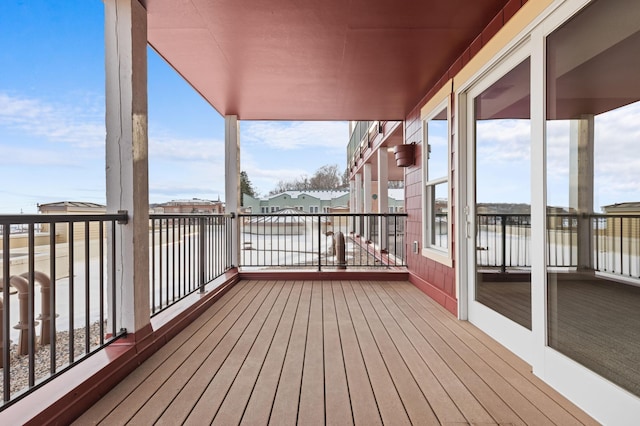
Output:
[0, 0, 640, 214]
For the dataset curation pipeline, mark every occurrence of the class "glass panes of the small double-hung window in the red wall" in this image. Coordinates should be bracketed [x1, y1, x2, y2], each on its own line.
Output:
[423, 101, 450, 256]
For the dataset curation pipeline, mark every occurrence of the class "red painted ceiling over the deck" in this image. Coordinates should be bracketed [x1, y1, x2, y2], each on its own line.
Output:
[144, 0, 507, 120]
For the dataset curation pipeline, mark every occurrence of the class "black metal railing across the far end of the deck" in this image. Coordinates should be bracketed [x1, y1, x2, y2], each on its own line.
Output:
[238, 213, 406, 270]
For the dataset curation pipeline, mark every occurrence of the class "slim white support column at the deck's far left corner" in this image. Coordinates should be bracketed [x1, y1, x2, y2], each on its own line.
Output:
[224, 115, 241, 267]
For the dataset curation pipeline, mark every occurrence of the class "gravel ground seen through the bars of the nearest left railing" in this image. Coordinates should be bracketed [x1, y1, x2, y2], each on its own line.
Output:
[0, 322, 106, 401]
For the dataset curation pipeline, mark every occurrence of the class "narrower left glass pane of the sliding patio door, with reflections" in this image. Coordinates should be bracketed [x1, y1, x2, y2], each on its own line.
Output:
[473, 58, 531, 330]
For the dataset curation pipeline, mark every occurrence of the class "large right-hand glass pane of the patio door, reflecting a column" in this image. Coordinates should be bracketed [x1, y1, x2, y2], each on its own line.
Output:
[546, 0, 640, 398]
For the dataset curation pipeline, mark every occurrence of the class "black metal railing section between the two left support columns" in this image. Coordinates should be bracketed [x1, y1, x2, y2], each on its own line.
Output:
[149, 214, 233, 316]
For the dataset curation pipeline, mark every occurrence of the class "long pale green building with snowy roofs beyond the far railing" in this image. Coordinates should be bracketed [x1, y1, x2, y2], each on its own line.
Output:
[243, 189, 404, 214]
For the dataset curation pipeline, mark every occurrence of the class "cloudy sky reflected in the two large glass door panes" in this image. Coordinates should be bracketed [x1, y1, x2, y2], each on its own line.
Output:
[476, 102, 640, 213]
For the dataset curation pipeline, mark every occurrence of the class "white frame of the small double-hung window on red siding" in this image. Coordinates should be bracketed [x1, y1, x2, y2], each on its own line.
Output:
[421, 96, 453, 267]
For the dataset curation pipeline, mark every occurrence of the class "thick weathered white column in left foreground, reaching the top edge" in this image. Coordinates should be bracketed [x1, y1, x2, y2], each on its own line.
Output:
[104, 0, 151, 340]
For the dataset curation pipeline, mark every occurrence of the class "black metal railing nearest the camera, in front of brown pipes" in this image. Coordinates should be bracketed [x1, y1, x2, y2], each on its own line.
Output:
[0, 213, 127, 410]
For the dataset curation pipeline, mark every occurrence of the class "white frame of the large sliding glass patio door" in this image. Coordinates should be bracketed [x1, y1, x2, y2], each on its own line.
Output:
[453, 0, 640, 424]
